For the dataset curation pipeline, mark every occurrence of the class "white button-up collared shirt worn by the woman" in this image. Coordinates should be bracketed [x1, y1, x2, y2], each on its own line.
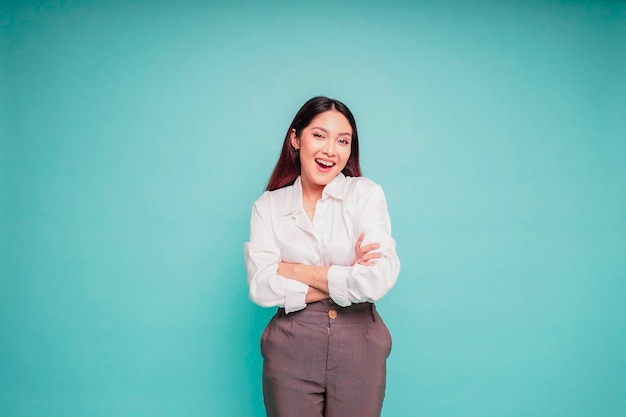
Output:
[244, 173, 400, 313]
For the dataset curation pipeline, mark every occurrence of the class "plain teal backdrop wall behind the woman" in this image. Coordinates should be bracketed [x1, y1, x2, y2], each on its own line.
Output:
[0, 0, 626, 417]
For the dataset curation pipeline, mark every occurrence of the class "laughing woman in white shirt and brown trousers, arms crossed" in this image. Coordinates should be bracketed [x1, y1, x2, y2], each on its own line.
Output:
[245, 97, 400, 417]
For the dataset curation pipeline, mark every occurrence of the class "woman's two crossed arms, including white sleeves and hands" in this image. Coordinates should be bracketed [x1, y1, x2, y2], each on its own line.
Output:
[244, 186, 400, 312]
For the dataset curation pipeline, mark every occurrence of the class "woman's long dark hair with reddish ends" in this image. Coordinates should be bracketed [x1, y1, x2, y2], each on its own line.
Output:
[266, 96, 361, 191]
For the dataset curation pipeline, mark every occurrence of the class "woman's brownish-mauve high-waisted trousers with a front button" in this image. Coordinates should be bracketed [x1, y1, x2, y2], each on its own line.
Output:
[261, 300, 391, 417]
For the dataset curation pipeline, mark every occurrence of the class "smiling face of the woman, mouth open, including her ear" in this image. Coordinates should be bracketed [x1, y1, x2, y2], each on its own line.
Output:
[291, 110, 352, 188]
